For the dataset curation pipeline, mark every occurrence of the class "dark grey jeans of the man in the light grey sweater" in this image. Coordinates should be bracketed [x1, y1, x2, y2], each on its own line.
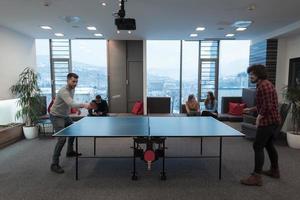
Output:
[50, 115, 75, 164]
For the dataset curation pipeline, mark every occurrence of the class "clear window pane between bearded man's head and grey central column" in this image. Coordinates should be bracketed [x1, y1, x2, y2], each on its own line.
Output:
[71, 40, 107, 102]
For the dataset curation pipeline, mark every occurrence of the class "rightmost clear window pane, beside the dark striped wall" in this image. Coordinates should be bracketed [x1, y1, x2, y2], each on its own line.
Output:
[218, 40, 250, 111]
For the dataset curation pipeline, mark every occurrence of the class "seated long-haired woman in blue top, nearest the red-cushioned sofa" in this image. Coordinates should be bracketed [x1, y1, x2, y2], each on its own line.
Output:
[202, 91, 218, 118]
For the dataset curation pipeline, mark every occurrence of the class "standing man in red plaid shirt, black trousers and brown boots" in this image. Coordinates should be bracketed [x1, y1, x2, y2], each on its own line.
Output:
[241, 65, 280, 186]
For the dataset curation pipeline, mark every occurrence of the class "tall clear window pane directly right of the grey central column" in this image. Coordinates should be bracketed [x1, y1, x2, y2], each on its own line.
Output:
[147, 40, 180, 112]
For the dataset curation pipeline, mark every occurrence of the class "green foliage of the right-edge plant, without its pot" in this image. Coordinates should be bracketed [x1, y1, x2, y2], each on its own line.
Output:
[283, 87, 300, 133]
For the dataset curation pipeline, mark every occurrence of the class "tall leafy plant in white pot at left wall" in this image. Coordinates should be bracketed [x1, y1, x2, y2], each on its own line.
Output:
[10, 67, 41, 139]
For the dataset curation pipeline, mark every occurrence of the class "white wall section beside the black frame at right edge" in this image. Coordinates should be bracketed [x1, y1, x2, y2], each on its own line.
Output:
[276, 35, 300, 101]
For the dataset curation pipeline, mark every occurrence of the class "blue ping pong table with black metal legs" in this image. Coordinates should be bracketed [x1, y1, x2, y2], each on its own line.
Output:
[54, 116, 244, 180]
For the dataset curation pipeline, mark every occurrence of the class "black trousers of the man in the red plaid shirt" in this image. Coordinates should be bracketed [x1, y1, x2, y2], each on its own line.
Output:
[253, 125, 278, 174]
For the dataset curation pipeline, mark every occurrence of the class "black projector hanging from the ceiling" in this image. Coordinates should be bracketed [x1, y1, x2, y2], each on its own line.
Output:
[115, 0, 136, 30]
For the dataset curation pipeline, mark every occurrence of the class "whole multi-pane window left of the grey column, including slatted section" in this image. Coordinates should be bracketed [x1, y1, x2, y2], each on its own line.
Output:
[36, 39, 107, 103]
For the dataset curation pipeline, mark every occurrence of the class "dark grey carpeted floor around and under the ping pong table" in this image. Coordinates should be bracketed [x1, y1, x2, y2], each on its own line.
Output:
[0, 122, 300, 200]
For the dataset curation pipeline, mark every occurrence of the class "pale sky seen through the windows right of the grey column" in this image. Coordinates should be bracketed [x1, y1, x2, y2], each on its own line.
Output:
[146, 40, 250, 79]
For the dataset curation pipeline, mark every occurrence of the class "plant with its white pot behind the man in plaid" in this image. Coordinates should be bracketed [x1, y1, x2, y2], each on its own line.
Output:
[284, 87, 300, 149]
